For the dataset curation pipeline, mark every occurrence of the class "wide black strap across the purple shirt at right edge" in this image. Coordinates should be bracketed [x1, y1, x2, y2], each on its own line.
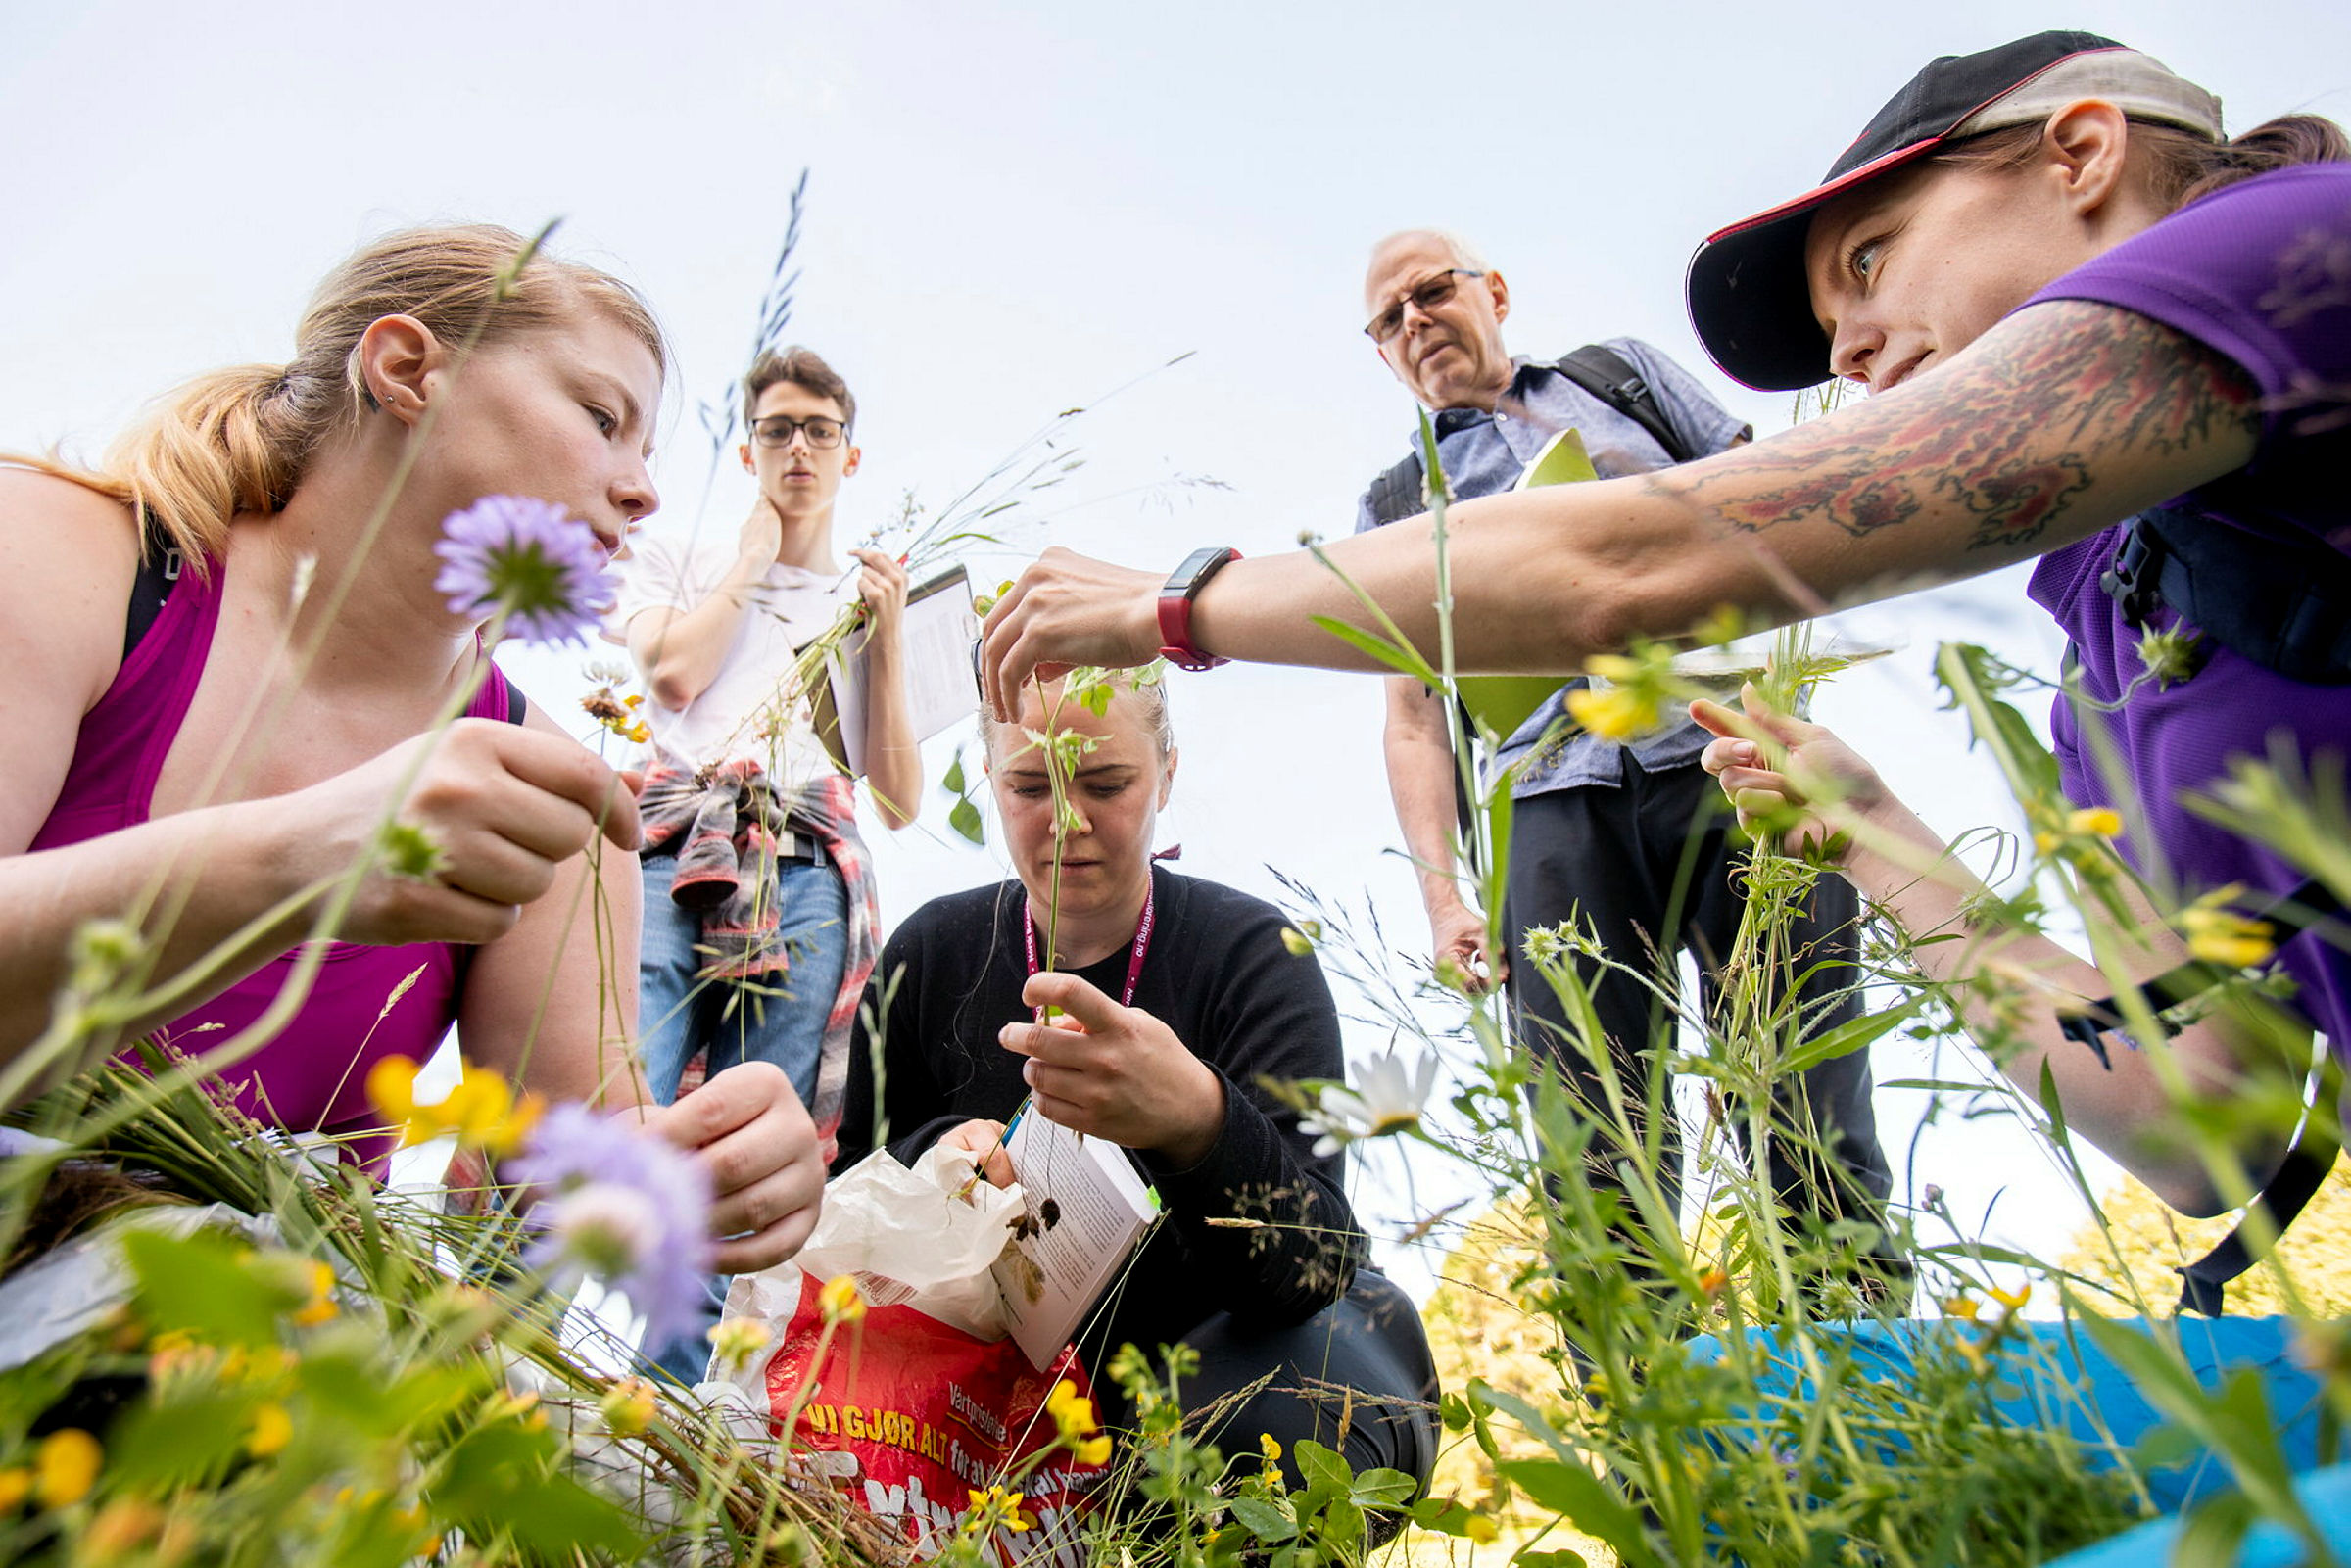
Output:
[2097, 507, 2351, 687]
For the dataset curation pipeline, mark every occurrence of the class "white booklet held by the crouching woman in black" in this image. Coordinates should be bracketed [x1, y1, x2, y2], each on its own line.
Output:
[994, 1110, 1159, 1370]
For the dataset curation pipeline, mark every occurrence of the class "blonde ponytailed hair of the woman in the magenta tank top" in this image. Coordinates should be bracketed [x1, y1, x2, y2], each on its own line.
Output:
[7, 223, 670, 571]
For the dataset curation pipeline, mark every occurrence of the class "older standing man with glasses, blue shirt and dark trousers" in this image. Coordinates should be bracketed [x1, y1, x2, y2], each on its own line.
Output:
[1357, 230, 1891, 1316]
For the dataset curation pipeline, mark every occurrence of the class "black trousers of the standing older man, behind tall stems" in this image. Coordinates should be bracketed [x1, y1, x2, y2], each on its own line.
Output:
[1503, 754, 1893, 1259]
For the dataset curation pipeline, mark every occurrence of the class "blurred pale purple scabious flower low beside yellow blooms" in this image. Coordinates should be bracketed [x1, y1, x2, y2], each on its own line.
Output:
[505, 1105, 715, 1345]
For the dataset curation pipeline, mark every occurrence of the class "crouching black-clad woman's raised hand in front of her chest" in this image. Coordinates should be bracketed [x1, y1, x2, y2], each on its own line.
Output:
[997, 971, 1224, 1168]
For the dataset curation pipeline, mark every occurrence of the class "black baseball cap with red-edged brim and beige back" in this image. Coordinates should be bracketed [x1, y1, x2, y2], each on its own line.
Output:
[1688, 33, 2220, 390]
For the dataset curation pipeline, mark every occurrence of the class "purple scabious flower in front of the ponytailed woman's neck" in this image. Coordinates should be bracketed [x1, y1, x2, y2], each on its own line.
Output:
[433, 496, 616, 646]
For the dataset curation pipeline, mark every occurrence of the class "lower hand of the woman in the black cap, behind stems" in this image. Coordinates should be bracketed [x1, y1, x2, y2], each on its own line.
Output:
[1691, 682, 1888, 865]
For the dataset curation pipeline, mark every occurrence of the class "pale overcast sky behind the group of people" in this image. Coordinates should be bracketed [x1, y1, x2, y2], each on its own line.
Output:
[0, 0, 2351, 1297]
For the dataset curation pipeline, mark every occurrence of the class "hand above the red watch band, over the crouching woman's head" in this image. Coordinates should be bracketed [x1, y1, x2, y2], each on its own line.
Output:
[981, 547, 1166, 724]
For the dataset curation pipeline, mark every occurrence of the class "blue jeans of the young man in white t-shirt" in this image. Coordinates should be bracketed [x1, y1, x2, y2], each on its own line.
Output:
[637, 856, 848, 1387]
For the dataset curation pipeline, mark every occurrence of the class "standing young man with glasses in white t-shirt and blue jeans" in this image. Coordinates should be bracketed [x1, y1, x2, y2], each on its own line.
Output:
[611, 346, 922, 1382]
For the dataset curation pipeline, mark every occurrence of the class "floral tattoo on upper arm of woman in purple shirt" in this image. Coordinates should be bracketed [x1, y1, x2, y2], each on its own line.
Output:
[1653, 301, 2259, 559]
